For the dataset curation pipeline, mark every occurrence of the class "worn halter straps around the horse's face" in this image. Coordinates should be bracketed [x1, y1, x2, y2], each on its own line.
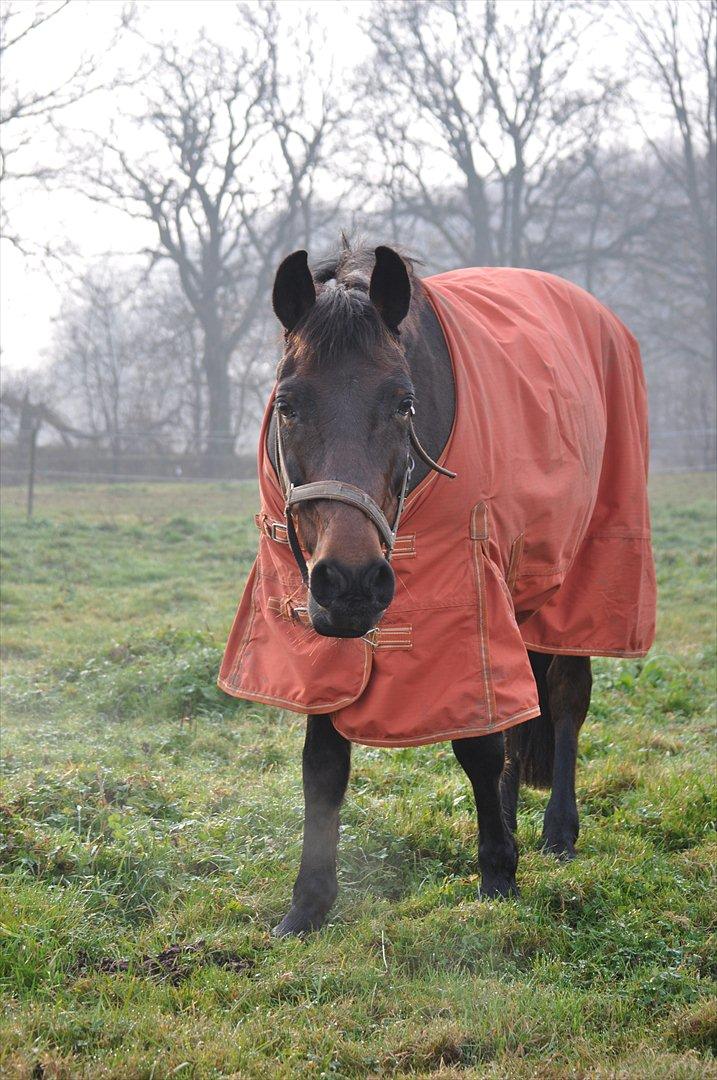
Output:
[276, 408, 456, 585]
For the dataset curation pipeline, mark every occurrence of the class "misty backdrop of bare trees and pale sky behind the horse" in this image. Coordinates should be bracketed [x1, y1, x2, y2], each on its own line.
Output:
[0, 0, 717, 478]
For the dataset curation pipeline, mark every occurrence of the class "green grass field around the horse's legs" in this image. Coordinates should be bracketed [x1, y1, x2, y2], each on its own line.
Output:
[0, 476, 717, 1080]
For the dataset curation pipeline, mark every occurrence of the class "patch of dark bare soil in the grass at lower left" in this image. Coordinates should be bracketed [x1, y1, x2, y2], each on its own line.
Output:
[72, 941, 256, 985]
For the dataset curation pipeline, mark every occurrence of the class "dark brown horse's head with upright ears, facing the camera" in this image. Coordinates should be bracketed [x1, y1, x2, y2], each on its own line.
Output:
[273, 247, 414, 637]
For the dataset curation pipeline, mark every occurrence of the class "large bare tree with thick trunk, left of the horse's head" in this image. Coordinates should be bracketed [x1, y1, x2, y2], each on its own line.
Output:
[80, 3, 339, 464]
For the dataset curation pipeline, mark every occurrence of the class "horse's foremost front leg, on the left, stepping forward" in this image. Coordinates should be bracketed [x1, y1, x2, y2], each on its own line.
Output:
[274, 716, 351, 937]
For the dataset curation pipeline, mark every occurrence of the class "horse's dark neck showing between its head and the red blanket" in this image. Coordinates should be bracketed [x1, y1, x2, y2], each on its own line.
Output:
[403, 285, 456, 488]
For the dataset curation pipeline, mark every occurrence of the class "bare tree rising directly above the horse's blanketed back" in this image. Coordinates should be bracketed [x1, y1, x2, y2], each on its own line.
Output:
[366, 0, 615, 266]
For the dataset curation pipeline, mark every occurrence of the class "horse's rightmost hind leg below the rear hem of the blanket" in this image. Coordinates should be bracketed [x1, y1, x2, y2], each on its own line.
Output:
[543, 657, 593, 859]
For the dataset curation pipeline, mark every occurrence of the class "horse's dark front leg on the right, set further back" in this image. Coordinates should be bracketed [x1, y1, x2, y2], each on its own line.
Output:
[451, 732, 518, 896]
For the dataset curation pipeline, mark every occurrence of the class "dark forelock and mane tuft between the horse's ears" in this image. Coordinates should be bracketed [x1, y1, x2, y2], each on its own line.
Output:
[290, 233, 416, 362]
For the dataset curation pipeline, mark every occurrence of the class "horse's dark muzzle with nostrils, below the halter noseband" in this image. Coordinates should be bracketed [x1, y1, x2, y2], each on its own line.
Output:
[309, 558, 395, 637]
